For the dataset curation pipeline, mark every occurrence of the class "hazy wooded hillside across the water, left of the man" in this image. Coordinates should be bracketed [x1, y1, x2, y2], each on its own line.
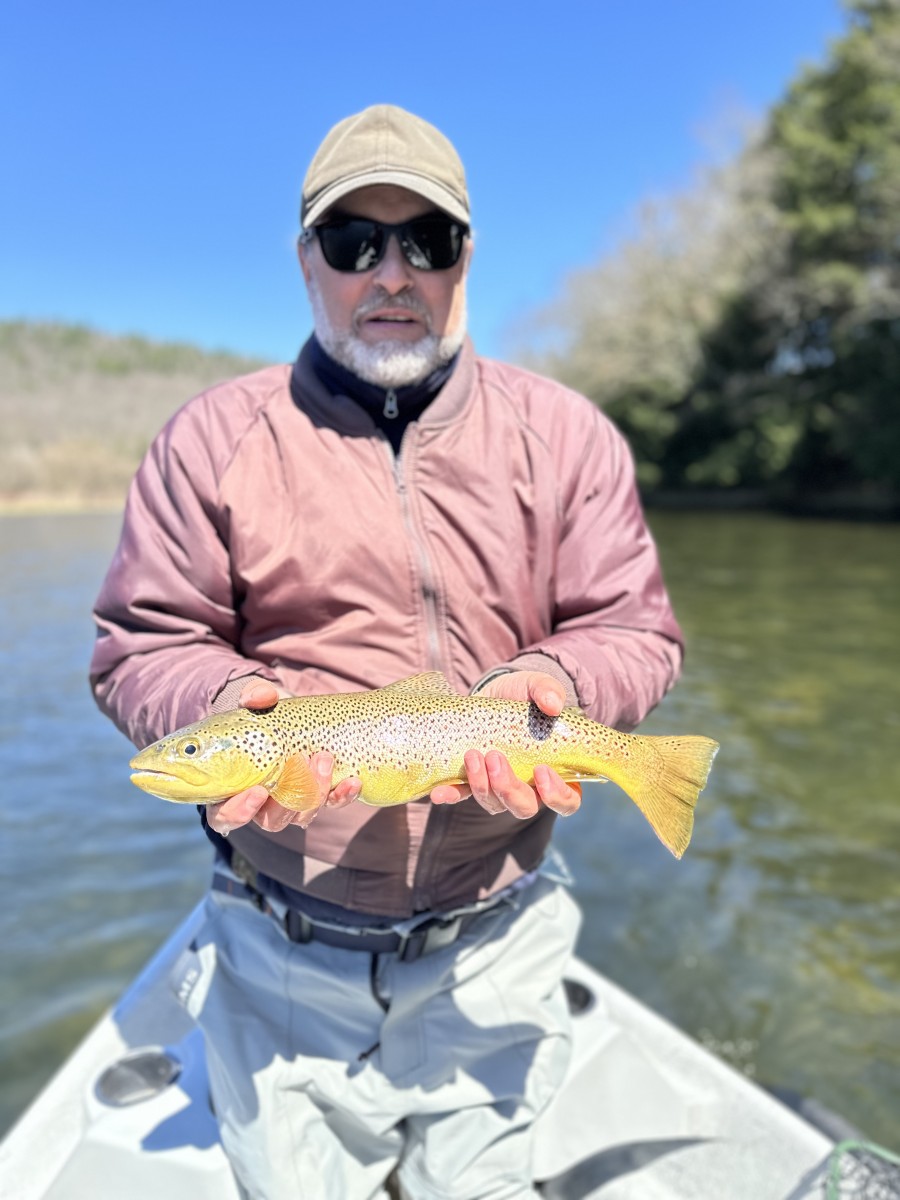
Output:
[0, 320, 270, 509]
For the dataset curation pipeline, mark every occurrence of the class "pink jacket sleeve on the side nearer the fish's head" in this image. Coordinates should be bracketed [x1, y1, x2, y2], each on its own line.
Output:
[90, 410, 277, 746]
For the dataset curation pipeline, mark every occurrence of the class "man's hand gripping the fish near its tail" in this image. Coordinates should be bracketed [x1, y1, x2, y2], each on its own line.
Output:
[431, 671, 581, 818]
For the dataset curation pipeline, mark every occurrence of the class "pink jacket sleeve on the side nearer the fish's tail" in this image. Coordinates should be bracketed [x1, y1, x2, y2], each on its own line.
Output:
[514, 406, 683, 730]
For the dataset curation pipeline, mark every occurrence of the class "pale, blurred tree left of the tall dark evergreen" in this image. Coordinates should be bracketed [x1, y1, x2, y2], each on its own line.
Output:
[521, 139, 784, 487]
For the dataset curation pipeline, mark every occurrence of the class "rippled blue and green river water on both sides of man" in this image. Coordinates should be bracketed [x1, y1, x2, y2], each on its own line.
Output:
[0, 514, 900, 1147]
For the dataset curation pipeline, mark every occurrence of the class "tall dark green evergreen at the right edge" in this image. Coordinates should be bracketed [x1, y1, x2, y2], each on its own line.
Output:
[768, 0, 900, 488]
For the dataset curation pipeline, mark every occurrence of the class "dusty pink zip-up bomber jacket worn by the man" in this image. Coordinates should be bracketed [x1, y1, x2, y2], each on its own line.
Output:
[91, 344, 682, 917]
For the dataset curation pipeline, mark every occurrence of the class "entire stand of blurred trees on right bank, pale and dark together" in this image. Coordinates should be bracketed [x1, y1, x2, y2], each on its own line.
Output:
[525, 0, 900, 497]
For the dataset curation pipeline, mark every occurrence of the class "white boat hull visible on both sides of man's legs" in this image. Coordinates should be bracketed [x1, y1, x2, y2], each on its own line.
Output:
[0, 905, 900, 1200]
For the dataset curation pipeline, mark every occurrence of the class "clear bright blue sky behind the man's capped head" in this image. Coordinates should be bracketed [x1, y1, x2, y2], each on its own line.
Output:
[0, 0, 845, 360]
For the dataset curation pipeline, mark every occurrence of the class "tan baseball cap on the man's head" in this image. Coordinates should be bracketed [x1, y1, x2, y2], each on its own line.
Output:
[300, 104, 469, 229]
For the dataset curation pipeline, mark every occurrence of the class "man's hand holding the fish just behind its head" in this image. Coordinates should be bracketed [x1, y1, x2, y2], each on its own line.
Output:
[206, 679, 362, 836]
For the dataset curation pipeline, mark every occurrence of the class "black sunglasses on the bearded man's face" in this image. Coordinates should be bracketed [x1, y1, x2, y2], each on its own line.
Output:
[300, 215, 469, 272]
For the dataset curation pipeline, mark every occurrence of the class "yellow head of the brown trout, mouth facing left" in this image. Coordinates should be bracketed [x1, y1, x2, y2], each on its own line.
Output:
[130, 709, 283, 804]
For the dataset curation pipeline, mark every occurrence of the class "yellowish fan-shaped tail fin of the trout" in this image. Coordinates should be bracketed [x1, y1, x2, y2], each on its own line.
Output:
[610, 737, 719, 858]
